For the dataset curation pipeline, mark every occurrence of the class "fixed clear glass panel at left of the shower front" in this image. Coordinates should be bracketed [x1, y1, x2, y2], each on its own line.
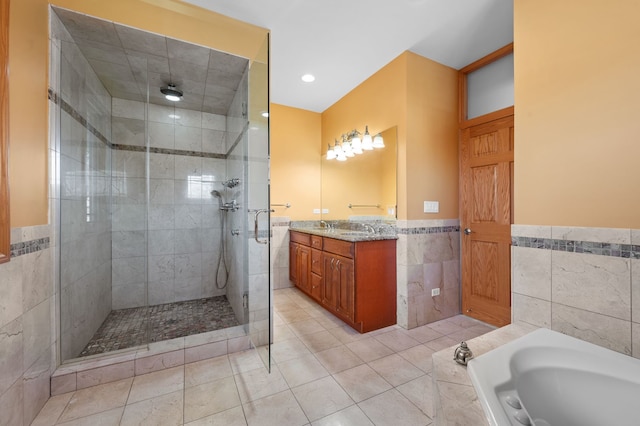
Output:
[51, 11, 148, 360]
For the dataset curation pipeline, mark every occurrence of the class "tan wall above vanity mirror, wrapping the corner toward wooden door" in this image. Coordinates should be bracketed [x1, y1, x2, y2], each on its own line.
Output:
[322, 52, 458, 220]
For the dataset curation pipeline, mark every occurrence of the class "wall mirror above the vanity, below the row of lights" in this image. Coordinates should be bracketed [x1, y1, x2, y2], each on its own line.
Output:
[321, 126, 398, 220]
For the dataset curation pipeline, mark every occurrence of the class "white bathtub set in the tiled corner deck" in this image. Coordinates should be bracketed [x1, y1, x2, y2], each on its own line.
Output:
[468, 328, 640, 426]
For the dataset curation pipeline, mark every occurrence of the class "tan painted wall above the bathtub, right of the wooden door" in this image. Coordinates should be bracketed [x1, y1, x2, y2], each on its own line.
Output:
[514, 0, 640, 229]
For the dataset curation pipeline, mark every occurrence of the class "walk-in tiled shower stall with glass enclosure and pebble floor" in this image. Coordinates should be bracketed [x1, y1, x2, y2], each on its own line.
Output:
[49, 8, 270, 361]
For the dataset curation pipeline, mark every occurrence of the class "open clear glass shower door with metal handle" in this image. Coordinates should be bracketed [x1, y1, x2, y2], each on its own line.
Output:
[245, 36, 272, 370]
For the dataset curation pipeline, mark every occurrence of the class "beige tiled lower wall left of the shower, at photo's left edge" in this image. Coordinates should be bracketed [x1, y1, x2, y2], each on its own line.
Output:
[0, 225, 56, 425]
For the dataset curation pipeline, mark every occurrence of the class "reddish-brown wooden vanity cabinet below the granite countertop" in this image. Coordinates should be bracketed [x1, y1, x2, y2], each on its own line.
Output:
[290, 231, 396, 333]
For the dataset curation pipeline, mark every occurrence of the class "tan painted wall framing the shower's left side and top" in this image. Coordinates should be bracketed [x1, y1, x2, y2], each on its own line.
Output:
[9, 0, 267, 227]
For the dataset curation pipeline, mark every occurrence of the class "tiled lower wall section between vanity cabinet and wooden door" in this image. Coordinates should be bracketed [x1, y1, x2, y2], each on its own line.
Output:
[397, 219, 460, 329]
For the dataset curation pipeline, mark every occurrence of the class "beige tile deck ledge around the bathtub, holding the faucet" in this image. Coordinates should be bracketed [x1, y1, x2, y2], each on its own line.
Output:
[432, 323, 537, 426]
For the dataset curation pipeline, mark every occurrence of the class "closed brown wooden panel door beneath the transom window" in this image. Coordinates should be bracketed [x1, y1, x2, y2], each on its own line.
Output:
[460, 115, 514, 326]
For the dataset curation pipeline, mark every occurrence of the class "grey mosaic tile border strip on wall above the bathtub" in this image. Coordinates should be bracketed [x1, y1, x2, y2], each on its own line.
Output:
[511, 236, 640, 259]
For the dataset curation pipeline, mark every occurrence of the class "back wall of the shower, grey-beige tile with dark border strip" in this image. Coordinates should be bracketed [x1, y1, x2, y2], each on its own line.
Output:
[112, 98, 229, 309]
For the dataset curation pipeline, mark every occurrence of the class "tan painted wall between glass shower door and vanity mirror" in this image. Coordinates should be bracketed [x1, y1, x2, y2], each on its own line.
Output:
[269, 104, 321, 220]
